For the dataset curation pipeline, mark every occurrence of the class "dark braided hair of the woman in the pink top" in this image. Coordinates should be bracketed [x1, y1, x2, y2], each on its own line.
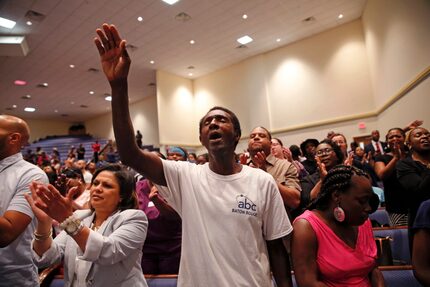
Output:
[309, 165, 368, 210]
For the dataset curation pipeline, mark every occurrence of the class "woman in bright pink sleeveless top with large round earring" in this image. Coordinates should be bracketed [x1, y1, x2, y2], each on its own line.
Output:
[292, 165, 385, 287]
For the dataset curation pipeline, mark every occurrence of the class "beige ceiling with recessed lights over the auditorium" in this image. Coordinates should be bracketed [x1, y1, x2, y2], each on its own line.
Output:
[0, 0, 366, 122]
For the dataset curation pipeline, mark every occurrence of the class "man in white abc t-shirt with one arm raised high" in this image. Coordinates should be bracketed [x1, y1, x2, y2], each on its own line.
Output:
[95, 24, 292, 287]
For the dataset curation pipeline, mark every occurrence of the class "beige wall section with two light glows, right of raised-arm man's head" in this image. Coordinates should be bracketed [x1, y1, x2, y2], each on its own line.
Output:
[265, 20, 375, 130]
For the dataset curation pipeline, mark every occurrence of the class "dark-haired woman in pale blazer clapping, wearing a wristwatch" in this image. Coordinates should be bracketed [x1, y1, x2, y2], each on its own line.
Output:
[26, 165, 148, 286]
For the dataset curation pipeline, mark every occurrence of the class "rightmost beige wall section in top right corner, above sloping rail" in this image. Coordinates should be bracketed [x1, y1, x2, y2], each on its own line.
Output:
[362, 0, 430, 107]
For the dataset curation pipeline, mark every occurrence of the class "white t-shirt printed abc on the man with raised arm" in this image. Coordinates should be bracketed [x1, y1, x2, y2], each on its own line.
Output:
[159, 160, 293, 287]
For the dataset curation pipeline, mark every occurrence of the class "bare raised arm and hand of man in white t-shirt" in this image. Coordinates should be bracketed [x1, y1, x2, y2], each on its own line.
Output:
[94, 24, 166, 185]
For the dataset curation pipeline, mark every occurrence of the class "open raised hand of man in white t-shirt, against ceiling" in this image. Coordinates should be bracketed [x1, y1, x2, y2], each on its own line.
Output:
[94, 24, 131, 83]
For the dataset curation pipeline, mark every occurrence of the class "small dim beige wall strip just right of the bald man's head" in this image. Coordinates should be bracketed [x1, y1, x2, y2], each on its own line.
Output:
[24, 119, 72, 142]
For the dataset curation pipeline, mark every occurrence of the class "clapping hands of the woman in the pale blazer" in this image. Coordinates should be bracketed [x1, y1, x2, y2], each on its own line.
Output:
[32, 184, 78, 225]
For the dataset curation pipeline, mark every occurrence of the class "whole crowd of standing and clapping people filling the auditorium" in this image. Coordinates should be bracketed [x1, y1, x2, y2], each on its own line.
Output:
[0, 24, 430, 286]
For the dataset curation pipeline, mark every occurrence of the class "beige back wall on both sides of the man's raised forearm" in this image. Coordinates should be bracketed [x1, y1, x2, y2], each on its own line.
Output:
[85, 96, 159, 146]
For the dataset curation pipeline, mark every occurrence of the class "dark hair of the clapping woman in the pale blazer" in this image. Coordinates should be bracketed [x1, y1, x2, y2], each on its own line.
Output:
[91, 164, 138, 211]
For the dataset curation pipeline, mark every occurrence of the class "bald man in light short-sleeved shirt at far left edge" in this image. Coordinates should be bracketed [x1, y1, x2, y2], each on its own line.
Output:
[0, 115, 48, 286]
